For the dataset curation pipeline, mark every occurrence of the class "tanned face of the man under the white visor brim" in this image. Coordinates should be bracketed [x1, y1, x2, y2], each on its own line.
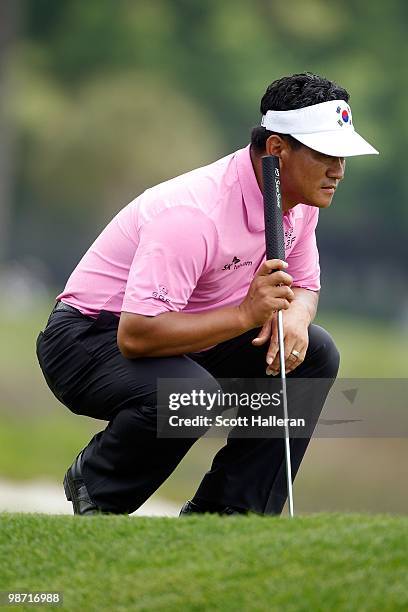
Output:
[281, 143, 346, 208]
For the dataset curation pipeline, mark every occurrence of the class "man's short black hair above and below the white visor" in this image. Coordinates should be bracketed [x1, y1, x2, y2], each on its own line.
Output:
[251, 72, 350, 153]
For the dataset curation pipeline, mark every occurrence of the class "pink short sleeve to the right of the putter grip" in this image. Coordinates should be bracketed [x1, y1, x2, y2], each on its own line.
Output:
[287, 207, 320, 291]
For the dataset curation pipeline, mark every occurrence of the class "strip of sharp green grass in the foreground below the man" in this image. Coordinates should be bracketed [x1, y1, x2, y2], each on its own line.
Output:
[0, 513, 408, 612]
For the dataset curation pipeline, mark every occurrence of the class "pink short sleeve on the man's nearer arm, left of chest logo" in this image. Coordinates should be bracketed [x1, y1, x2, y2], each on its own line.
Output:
[121, 206, 216, 316]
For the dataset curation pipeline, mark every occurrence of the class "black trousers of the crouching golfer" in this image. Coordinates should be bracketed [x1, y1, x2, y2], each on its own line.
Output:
[36, 310, 339, 514]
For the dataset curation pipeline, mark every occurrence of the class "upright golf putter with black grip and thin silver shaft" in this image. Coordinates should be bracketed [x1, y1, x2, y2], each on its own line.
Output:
[262, 155, 294, 517]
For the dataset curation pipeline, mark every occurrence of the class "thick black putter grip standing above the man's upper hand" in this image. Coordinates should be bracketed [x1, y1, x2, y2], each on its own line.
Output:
[262, 155, 285, 261]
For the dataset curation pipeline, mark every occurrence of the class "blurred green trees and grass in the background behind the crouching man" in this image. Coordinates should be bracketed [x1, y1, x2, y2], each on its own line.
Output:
[0, 0, 408, 511]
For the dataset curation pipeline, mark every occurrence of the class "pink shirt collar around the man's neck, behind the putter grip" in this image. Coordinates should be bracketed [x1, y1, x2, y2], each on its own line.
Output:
[235, 145, 303, 232]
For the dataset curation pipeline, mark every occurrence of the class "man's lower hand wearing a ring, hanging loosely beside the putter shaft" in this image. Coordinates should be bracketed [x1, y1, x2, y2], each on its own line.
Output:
[252, 300, 311, 376]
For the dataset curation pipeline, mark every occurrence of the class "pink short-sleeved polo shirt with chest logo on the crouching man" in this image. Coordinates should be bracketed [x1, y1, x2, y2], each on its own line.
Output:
[56, 146, 320, 316]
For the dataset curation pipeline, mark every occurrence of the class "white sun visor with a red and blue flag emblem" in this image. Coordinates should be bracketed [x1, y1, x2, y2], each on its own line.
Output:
[261, 100, 378, 157]
